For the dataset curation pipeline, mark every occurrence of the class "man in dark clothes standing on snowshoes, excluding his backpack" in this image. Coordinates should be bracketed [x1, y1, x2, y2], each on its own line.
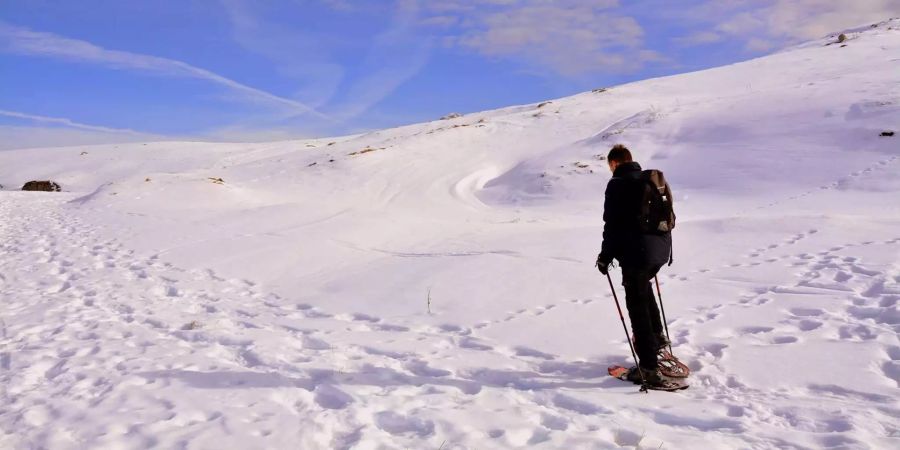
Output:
[597, 145, 672, 384]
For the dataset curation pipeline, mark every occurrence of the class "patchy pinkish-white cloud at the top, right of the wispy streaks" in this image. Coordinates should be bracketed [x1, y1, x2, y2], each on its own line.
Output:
[423, 0, 662, 76]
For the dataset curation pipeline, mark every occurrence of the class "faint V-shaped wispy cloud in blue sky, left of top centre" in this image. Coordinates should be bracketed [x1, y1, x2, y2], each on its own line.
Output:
[221, 0, 431, 122]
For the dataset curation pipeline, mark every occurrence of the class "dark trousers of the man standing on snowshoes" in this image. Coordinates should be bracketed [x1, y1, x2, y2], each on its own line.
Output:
[622, 267, 663, 370]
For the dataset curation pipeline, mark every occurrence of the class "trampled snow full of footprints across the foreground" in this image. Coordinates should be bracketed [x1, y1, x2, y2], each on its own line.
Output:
[0, 194, 900, 448]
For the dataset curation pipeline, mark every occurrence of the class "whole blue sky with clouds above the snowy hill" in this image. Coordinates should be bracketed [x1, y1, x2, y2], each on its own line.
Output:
[0, 0, 900, 148]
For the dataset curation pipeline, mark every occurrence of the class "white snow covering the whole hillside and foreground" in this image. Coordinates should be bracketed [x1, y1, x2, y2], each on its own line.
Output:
[0, 19, 900, 449]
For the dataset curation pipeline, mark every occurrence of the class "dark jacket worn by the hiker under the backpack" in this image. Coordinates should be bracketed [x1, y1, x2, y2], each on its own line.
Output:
[600, 162, 672, 272]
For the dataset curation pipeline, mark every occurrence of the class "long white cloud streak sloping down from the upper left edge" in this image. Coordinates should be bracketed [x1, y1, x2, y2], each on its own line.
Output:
[0, 22, 327, 118]
